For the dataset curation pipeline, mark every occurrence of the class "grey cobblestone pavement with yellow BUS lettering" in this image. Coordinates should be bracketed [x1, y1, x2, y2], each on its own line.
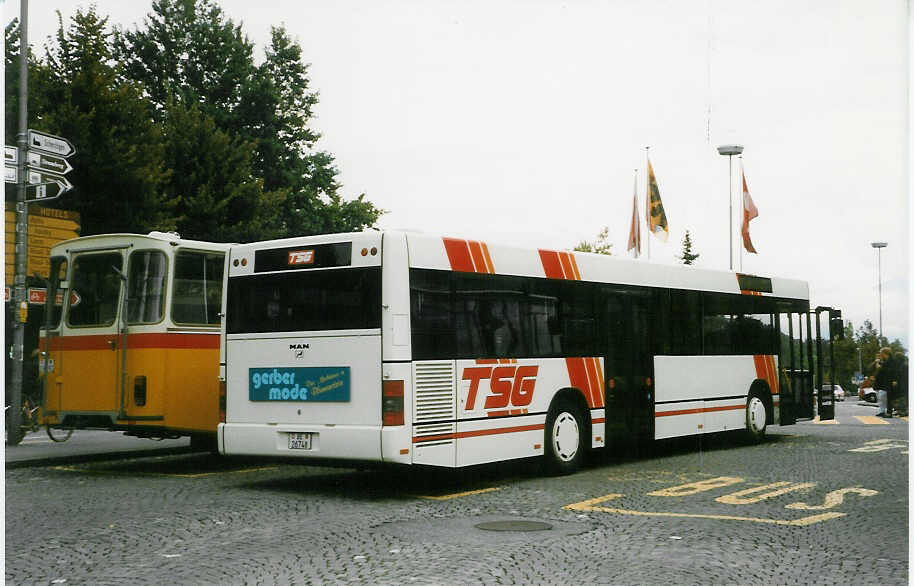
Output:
[5, 406, 908, 585]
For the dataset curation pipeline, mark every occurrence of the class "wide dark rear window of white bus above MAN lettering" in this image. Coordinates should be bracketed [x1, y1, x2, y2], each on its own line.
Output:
[226, 267, 381, 334]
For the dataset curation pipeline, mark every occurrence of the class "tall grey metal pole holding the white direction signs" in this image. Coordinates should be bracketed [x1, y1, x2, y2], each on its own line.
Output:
[6, 0, 29, 445]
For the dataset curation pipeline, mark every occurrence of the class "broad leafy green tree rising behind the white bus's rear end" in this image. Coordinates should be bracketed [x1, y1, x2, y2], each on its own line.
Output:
[114, 0, 383, 239]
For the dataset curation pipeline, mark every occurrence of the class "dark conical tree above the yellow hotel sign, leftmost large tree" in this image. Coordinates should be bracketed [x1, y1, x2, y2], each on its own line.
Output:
[24, 8, 174, 234]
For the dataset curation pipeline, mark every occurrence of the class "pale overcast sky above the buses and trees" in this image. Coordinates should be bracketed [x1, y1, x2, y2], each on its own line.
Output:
[3, 0, 912, 346]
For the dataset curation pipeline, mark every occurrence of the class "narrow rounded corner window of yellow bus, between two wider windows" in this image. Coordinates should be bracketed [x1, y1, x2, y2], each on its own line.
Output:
[127, 250, 168, 324]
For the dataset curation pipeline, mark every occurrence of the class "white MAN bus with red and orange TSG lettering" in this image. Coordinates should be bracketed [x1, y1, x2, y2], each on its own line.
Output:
[218, 232, 833, 472]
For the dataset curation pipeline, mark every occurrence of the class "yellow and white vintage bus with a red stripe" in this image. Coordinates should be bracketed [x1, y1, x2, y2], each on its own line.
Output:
[41, 232, 228, 448]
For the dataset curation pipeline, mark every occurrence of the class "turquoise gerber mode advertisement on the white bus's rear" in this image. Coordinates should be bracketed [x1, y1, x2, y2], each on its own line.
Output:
[248, 366, 350, 402]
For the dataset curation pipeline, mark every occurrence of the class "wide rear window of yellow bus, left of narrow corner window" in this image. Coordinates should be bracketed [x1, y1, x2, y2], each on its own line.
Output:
[67, 252, 123, 326]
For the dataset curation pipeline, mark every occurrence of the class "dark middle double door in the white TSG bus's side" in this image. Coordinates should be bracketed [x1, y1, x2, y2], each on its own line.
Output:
[599, 288, 654, 445]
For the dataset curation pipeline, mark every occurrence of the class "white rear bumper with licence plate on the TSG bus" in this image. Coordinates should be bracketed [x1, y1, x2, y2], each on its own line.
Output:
[218, 423, 381, 461]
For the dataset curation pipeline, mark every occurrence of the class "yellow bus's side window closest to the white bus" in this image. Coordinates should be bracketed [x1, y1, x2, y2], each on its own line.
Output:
[171, 250, 225, 325]
